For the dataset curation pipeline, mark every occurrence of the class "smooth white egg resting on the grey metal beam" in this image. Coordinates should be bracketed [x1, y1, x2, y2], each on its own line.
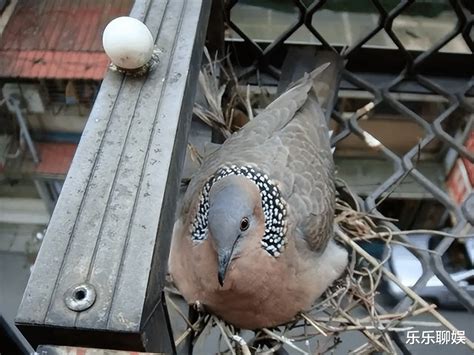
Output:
[102, 16, 153, 69]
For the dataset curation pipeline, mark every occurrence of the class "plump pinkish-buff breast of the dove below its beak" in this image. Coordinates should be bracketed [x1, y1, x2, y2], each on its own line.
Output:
[171, 228, 315, 329]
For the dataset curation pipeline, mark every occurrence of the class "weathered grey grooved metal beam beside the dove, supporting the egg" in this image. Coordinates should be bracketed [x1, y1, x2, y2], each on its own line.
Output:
[16, 0, 210, 352]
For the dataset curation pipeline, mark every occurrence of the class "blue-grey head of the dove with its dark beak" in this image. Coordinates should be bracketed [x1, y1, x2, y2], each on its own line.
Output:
[208, 175, 265, 286]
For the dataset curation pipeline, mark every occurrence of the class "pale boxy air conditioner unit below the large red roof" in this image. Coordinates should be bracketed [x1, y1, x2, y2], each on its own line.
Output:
[2, 83, 45, 113]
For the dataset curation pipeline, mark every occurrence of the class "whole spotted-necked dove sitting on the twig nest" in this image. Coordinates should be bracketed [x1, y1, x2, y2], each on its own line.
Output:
[169, 65, 347, 329]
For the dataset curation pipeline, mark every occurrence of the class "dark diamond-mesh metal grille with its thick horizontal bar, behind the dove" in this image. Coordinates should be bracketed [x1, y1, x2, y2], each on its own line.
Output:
[223, 0, 474, 311]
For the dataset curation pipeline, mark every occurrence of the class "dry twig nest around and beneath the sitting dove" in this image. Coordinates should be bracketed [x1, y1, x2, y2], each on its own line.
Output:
[168, 54, 473, 355]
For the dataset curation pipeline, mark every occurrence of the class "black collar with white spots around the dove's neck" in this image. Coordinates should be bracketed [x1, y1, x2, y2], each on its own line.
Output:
[191, 165, 287, 257]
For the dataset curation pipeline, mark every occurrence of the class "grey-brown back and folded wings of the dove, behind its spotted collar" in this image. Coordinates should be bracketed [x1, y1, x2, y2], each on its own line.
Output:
[182, 66, 334, 250]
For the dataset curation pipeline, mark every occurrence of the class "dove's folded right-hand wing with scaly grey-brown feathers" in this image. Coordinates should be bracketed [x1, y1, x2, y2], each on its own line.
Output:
[284, 105, 335, 251]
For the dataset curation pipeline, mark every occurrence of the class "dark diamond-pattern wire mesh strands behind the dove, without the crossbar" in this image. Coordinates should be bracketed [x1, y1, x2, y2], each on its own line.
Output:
[226, 0, 474, 312]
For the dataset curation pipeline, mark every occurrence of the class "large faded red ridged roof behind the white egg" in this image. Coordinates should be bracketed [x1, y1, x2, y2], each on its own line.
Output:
[0, 0, 133, 80]
